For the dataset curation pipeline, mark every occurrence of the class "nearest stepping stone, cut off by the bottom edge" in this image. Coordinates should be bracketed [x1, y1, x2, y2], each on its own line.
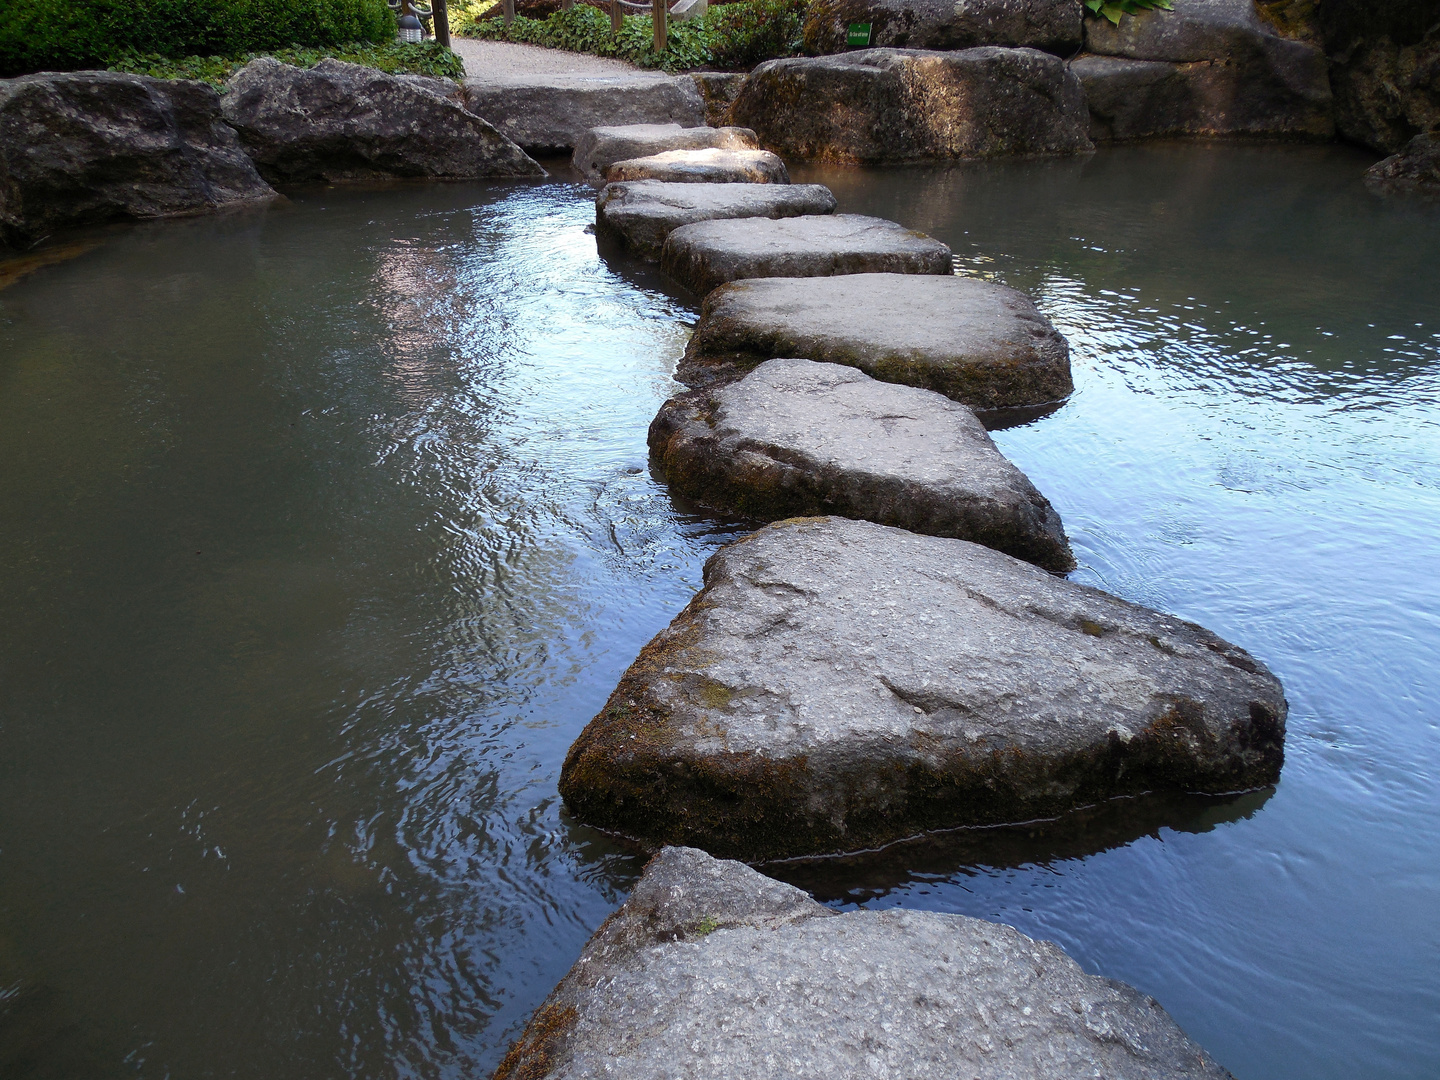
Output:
[497, 847, 1234, 1080]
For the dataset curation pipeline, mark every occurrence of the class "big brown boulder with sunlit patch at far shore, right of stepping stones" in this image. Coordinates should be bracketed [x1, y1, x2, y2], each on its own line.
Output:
[730, 48, 1093, 164]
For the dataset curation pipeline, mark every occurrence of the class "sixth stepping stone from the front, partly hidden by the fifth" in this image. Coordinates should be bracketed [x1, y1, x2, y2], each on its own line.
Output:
[595, 180, 835, 262]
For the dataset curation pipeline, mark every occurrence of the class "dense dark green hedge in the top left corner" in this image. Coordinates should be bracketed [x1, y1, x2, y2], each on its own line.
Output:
[0, 0, 395, 76]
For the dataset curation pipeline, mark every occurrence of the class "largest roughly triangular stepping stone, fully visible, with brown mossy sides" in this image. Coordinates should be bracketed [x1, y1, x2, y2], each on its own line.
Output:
[560, 517, 1286, 861]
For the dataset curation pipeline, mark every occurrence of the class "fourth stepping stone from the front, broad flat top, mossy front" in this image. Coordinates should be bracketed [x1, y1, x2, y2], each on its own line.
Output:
[682, 272, 1074, 409]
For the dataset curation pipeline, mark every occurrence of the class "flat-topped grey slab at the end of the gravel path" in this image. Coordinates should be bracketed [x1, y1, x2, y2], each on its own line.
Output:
[465, 72, 706, 154]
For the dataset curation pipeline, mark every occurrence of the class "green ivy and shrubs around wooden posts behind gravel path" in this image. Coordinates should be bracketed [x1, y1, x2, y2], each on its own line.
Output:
[466, 0, 805, 72]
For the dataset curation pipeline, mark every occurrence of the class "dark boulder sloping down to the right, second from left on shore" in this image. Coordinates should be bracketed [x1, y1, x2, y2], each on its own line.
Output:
[223, 56, 544, 183]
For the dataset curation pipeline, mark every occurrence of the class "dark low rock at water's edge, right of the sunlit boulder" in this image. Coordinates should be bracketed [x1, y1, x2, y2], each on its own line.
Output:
[1070, 49, 1335, 143]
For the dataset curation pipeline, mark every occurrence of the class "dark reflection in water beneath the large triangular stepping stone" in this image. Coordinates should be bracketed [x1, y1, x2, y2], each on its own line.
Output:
[763, 788, 1274, 903]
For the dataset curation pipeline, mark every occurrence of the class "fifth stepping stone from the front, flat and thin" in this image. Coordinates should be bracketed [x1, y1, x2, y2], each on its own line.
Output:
[660, 213, 950, 298]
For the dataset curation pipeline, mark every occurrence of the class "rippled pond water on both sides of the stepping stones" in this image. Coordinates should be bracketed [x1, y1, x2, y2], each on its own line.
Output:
[0, 147, 1440, 1080]
